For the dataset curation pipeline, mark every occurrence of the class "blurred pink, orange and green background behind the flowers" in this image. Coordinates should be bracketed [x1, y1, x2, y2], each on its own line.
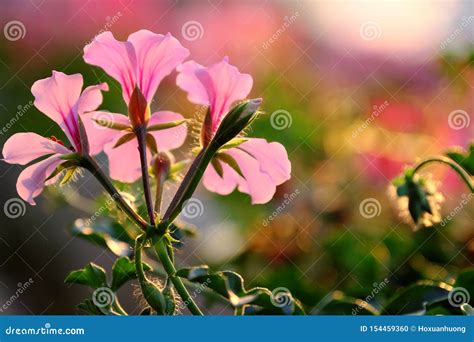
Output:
[0, 0, 474, 314]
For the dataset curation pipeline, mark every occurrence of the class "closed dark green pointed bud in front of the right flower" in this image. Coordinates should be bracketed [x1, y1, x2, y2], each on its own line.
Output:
[212, 98, 262, 146]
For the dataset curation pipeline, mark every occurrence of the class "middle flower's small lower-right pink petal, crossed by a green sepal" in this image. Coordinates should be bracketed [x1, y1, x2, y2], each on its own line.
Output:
[148, 111, 187, 151]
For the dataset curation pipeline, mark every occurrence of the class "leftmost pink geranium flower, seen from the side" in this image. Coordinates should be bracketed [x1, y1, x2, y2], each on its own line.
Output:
[2, 71, 108, 205]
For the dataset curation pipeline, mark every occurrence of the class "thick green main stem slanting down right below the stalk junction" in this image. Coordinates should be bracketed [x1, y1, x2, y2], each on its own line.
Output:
[155, 237, 203, 316]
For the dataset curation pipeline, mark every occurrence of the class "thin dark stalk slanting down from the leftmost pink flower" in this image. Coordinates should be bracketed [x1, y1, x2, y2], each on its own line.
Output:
[80, 156, 148, 231]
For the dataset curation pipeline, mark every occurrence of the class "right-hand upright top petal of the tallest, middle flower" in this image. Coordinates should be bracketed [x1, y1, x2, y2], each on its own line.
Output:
[128, 30, 189, 103]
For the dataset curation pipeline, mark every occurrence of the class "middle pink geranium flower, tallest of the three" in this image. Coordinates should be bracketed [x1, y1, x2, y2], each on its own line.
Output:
[84, 30, 189, 182]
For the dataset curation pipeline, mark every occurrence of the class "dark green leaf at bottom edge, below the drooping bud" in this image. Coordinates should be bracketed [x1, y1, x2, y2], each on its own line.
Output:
[381, 280, 452, 315]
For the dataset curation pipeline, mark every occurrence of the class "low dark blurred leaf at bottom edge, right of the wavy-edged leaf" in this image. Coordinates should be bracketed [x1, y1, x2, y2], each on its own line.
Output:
[314, 291, 380, 316]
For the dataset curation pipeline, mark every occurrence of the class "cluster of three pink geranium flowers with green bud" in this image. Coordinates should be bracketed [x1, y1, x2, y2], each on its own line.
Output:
[3, 30, 291, 205]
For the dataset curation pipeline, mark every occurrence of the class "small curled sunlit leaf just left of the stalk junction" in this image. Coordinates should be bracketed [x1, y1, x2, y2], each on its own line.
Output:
[71, 216, 138, 256]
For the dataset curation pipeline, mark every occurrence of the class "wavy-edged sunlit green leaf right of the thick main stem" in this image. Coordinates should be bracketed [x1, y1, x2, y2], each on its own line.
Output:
[176, 265, 305, 315]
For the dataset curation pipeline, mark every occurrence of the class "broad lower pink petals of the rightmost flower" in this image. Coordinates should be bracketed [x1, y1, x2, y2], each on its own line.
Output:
[203, 139, 291, 204]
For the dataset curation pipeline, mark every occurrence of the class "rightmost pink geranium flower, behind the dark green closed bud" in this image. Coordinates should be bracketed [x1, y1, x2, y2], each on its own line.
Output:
[177, 58, 291, 204]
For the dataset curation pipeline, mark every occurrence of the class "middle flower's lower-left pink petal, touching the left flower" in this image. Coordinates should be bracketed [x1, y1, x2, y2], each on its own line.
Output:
[81, 111, 130, 155]
